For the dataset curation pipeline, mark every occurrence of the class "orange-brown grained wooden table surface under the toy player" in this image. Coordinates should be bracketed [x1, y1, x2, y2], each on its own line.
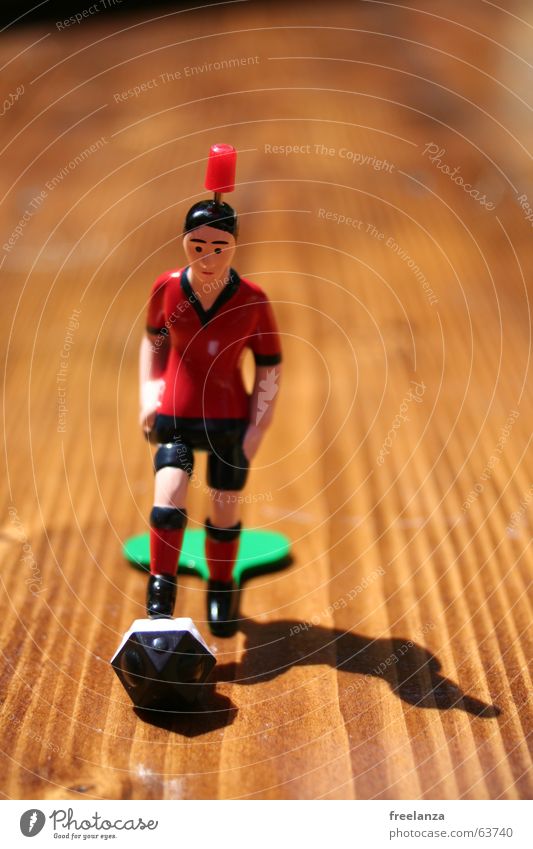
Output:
[0, 0, 533, 799]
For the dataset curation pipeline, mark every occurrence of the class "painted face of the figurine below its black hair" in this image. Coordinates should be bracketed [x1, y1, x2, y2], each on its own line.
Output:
[183, 227, 235, 283]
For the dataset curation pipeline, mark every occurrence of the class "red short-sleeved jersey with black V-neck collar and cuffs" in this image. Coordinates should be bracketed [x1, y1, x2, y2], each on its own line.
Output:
[143, 268, 281, 419]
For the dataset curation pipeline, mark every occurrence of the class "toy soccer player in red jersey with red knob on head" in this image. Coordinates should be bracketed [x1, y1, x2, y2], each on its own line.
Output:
[140, 145, 281, 636]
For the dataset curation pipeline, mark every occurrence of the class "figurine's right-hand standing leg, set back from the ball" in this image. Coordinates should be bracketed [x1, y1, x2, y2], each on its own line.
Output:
[205, 434, 248, 637]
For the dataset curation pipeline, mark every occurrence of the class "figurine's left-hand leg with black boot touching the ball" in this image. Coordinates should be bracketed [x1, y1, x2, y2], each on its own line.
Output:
[146, 444, 193, 618]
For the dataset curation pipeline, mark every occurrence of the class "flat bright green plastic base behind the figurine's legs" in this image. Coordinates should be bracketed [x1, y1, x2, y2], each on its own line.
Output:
[123, 529, 290, 584]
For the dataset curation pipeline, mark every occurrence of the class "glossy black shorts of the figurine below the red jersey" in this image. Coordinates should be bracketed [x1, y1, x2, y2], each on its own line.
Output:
[150, 415, 249, 490]
